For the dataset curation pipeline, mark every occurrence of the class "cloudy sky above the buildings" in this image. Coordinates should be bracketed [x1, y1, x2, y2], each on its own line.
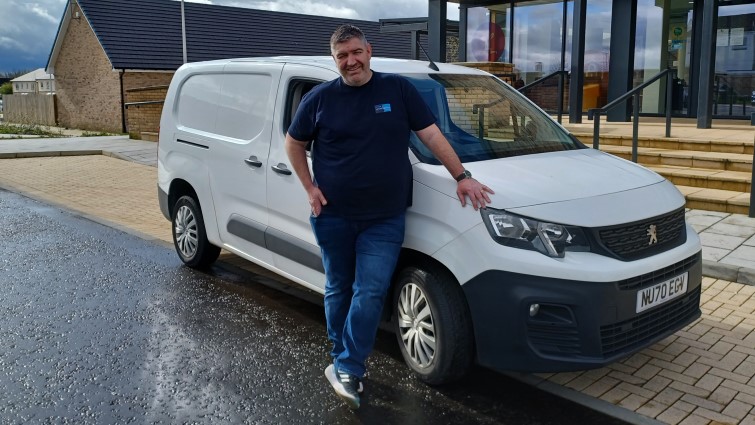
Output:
[0, 0, 459, 73]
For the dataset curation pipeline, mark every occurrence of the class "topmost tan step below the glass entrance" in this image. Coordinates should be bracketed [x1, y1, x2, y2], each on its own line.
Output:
[574, 132, 755, 157]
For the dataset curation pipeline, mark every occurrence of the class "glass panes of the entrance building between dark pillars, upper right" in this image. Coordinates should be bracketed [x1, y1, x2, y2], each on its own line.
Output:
[462, 0, 755, 119]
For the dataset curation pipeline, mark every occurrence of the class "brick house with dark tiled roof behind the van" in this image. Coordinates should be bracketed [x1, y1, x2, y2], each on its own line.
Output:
[47, 0, 426, 137]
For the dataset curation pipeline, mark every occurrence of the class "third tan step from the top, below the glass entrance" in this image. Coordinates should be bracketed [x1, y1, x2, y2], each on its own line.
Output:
[647, 165, 752, 192]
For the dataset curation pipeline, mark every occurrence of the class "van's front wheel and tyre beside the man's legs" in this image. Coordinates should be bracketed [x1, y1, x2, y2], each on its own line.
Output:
[393, 266, 474, 385]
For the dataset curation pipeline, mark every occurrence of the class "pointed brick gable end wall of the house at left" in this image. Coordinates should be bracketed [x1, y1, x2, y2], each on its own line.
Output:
[54, 4, 122, 132]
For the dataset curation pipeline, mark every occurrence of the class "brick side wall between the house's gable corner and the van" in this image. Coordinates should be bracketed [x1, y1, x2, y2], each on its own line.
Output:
[123, 72, 173, 141]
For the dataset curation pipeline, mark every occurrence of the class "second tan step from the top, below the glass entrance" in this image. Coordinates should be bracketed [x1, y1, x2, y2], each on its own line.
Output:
[601, 145, 752, 173]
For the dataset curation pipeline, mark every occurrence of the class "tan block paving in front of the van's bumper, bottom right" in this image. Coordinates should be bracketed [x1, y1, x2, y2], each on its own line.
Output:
[537, 277, 755, 425]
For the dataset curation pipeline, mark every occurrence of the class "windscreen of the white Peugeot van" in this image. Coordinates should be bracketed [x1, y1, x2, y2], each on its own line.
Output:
[404, 74, 585, 164]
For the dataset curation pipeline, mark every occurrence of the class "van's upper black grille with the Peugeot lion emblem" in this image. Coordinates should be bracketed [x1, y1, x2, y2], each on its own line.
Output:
[597, 208, 687, 260]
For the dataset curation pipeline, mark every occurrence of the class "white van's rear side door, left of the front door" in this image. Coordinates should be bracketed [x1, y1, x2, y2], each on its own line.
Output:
[210, 62, 283, 266]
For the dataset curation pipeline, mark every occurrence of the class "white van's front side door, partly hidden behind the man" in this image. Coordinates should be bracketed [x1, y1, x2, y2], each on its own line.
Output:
[267, 64, 338, 292]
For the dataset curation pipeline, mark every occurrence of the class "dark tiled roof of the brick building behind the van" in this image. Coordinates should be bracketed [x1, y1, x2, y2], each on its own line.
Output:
[47, 0, 420, 71]
